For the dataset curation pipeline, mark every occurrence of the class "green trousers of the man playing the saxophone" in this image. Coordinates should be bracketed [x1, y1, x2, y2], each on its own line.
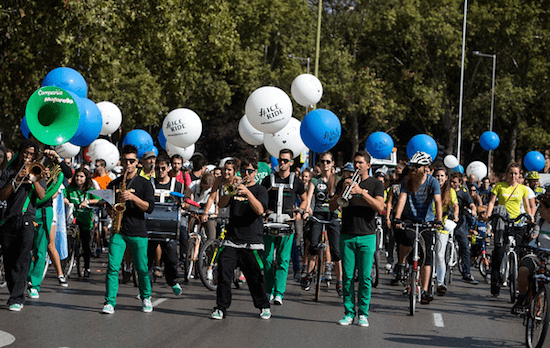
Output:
[105, 233, 151, 307]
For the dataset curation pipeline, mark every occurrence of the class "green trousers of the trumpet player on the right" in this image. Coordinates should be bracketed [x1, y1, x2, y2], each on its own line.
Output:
[340, 233, 376, 316]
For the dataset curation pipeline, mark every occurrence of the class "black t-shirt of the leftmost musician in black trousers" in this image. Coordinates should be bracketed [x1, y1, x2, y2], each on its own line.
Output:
[0, 168, 37, 221]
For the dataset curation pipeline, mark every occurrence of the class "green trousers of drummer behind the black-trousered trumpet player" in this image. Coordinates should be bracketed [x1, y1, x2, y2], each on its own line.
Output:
[263, 234, 294, 297]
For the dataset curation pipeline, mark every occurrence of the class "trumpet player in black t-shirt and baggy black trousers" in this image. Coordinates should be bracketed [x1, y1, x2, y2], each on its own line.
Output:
[211, 158, 271, 319]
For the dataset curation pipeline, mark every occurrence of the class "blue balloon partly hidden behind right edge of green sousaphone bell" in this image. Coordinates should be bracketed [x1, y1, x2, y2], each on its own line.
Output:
[69, 98, 103, 146]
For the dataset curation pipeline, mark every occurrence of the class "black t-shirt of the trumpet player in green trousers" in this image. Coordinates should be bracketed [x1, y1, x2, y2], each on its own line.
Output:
[336, 177, 384, 236]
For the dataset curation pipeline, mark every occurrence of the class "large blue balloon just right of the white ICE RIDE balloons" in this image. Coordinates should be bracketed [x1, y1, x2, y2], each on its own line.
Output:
[300, 109, 342, 152]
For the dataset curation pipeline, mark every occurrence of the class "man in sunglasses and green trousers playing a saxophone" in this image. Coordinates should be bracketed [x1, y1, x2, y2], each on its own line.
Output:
[102, 145, 155, 314]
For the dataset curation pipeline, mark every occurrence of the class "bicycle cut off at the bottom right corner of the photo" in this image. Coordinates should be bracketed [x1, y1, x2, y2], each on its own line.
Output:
[523, 248, 550, 348]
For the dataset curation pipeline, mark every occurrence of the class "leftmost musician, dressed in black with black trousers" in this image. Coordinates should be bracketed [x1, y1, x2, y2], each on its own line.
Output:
[0, 140, 45, 312]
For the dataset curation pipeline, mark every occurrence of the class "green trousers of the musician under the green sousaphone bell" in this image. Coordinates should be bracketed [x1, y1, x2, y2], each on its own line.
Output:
[27, 207, 53, 291]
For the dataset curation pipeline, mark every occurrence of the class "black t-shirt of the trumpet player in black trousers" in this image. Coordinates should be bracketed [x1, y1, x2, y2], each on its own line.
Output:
[226, 184, 267, 244]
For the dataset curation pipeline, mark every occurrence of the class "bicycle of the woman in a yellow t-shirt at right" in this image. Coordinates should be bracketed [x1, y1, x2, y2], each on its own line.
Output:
[491, 213, 531, 303]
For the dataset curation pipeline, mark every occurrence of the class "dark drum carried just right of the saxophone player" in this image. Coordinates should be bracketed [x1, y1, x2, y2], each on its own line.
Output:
[145, 203, 181, 242]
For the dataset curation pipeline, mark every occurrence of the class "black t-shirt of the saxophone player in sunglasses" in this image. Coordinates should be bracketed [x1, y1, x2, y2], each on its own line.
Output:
[107, 175, 155, 237]
